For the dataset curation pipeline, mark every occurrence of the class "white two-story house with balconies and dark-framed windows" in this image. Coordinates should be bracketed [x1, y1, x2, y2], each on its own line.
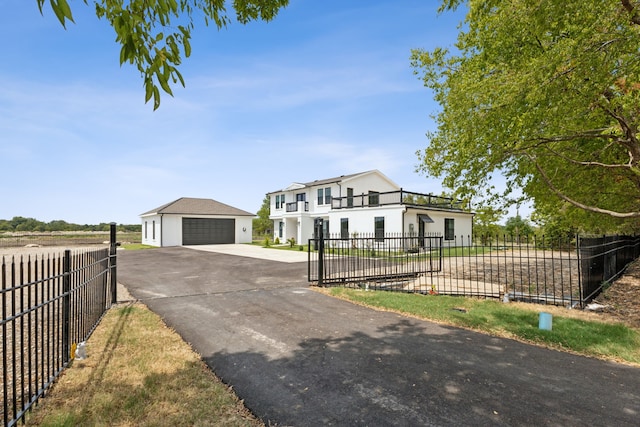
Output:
[268, 170, 473, 245]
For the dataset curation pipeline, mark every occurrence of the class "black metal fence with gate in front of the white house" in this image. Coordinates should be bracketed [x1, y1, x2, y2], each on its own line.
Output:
[308, 235, 640, 307]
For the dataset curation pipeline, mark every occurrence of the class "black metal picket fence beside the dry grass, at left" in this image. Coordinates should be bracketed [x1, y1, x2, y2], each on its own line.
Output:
[0, 224, 117, 426]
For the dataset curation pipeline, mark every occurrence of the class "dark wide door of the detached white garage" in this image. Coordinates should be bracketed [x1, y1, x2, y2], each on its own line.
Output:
[182, 218, 236, 245]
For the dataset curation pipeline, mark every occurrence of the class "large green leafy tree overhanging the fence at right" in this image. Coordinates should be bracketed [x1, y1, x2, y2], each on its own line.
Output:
[412, 0, 640, 234]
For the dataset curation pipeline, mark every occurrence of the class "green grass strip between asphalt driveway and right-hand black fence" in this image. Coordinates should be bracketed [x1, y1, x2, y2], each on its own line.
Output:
[327, 288, 640, 365]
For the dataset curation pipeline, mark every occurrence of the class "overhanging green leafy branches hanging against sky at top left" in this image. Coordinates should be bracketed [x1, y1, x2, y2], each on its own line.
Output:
[36, 0, 289, 110]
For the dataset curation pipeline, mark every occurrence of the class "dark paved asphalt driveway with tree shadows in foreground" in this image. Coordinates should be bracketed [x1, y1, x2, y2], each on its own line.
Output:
[118, 248, 640, 426]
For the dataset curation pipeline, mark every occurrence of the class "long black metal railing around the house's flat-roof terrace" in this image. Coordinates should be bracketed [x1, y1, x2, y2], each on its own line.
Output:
[331, 190, 467, 211]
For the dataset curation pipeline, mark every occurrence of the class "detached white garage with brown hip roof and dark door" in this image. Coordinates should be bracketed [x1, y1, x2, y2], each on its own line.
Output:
[140, 197, 255, 246]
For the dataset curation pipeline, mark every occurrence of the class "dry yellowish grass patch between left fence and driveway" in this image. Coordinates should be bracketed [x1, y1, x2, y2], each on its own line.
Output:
[27, 304, 263, 426]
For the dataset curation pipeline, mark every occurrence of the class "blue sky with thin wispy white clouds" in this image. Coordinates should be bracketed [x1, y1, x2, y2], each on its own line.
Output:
[0, 0, 480, 224]
